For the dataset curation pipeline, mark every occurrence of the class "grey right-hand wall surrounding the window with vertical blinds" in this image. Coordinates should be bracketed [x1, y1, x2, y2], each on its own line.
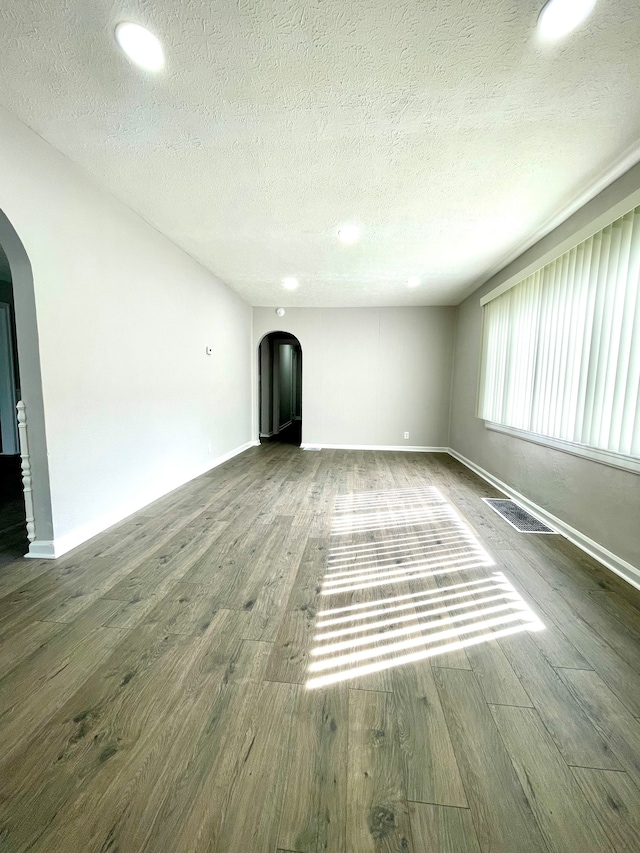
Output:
[451, 160, 640, 569]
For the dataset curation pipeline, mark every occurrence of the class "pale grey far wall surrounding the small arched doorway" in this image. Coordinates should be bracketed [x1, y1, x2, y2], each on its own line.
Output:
[253, 308, 455, 447]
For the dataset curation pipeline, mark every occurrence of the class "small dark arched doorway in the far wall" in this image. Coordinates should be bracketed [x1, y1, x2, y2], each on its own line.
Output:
[258, 332, 302, 447]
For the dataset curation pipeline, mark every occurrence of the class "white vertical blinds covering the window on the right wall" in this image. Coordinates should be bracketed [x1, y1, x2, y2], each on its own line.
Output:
[478, 207, 640, 458]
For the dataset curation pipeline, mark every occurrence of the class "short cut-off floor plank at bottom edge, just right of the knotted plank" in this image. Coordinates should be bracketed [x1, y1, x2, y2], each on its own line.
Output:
[409, 803, 481, 853]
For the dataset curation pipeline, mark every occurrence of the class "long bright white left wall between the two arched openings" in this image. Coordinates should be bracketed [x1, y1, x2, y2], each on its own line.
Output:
[0, 106, 252, 550]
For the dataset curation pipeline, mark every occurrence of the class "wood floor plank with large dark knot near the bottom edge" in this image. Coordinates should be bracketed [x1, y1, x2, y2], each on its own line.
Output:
[346, 690, 414, 853]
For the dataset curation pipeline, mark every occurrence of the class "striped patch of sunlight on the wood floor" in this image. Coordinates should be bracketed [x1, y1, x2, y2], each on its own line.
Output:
[307, 488, 544, 688]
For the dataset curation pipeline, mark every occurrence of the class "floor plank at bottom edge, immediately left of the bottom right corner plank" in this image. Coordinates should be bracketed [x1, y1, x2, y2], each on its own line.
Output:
[490, 705, 614, 853]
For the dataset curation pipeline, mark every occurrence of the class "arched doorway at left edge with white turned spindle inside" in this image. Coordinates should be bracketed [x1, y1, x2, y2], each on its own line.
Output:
[0, 211, 53, 568]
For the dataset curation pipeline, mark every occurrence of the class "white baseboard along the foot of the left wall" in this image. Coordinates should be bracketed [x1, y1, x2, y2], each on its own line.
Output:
[25, 441, 260, 560]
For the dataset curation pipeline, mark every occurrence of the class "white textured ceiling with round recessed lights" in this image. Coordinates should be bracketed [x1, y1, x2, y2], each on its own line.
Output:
[0, 0, 640, 306]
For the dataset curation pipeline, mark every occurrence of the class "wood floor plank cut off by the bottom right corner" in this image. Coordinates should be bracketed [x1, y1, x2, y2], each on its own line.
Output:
[572, 767, 640, 853]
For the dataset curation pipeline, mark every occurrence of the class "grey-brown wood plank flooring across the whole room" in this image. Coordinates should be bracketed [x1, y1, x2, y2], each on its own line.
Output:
[0, 444, 640, 853]
